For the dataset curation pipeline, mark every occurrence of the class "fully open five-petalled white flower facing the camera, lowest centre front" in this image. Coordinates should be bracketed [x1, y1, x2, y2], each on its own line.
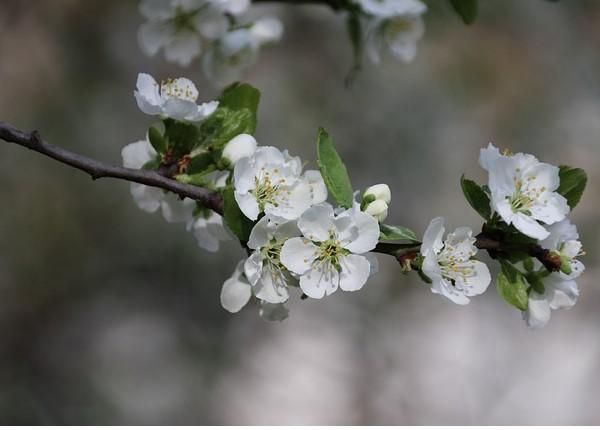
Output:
[281, 203, 379, 299]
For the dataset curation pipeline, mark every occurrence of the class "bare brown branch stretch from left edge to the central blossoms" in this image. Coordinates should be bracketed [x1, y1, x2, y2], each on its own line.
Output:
[0, 121, 223, 214]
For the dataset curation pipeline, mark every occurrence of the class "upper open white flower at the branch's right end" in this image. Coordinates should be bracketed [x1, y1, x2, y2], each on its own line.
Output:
[479, 143, 569, 240]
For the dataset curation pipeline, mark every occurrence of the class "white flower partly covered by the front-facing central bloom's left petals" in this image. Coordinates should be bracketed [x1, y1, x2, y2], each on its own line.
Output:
[244, 216, 300, 303]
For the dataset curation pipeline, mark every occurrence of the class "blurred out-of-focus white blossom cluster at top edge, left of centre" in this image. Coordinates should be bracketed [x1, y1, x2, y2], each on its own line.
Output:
[139, 0, 283, 84]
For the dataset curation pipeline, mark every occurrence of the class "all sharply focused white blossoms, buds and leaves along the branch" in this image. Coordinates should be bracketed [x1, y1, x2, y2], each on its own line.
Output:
[122, 74, 586, 328]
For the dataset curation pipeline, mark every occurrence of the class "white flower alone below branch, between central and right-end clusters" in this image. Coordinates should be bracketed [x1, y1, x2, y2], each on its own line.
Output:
[421, 218, 491, 305]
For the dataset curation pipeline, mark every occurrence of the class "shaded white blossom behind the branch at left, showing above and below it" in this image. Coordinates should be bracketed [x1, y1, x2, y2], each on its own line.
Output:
[121, 139, 196, 223]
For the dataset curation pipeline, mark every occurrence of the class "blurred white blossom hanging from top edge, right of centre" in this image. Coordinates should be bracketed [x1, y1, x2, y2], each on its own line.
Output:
[356, 0, 427, 63]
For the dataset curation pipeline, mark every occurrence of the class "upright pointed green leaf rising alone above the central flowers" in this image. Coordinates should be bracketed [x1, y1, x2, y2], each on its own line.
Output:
[317, 127, 354, 208]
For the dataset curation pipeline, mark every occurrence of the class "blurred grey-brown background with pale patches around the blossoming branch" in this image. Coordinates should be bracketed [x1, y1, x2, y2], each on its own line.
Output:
[0, 0, 600, 424]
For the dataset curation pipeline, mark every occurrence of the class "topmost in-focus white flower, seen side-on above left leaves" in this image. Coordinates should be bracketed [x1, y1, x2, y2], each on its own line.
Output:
[134, 73, 219, 122]
